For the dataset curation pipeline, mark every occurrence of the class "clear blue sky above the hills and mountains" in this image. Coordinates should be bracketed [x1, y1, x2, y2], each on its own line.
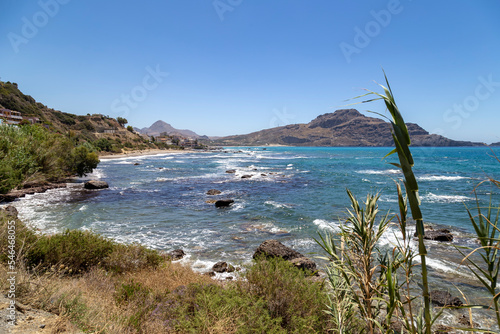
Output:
[0, 0, 500, 143]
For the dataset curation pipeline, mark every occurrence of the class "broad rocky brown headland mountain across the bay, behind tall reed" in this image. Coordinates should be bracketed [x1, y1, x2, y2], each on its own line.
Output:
[214, 109, 485, 146]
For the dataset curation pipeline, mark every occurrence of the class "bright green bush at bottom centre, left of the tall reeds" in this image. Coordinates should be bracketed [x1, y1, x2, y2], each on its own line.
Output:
[123, 259, 329, 333]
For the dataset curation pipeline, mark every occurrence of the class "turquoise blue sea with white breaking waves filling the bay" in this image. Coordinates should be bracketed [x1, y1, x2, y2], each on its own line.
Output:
[9, 147, 500, 273]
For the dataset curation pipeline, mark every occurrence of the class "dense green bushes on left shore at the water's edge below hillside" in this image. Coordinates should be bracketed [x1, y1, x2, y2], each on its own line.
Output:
[0, 125, 99, 193]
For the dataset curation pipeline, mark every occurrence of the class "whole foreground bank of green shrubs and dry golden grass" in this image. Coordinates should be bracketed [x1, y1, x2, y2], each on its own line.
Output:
[0, 210, 330, 334]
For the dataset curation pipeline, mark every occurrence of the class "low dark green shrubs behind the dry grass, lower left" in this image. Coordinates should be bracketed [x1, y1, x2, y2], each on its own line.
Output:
[0, 212, 164, 274]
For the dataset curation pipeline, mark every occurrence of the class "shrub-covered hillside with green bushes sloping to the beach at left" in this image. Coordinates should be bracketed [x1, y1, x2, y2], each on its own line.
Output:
[0, 81, 185, 194]
